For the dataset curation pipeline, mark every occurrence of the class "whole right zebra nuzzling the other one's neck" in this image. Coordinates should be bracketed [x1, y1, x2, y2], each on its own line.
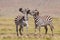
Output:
[29, 10, 54, 35]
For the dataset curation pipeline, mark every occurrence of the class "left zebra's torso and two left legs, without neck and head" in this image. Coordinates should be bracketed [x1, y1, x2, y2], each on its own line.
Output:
[14, 15, 27, 36]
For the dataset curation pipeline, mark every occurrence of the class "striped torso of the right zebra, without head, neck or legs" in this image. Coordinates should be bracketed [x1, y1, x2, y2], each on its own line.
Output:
[34, 16, 52, 25]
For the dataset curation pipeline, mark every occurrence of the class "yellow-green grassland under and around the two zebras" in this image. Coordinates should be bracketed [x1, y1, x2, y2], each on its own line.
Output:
[0, 17, 60, 40]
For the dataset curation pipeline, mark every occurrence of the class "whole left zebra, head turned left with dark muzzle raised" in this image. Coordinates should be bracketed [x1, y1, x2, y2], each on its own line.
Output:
[15, 8, 30, 36]
